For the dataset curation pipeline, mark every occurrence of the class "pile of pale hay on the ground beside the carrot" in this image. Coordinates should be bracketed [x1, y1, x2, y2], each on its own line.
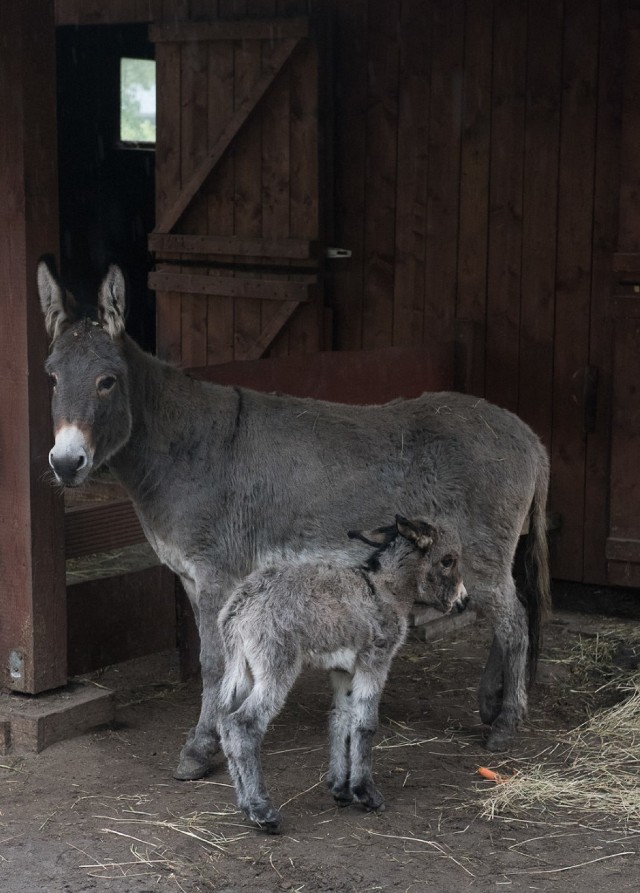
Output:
[481, 635, 640, 828]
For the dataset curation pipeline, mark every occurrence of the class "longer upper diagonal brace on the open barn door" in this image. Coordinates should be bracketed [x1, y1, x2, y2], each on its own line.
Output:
[154, 38, 300, 233]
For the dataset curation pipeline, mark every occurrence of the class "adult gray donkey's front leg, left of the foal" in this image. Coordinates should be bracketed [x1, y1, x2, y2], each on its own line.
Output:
[173, 578, 224, 781]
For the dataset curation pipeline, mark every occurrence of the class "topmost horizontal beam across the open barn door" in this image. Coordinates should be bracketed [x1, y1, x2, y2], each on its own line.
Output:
[149, 16, 309, 43]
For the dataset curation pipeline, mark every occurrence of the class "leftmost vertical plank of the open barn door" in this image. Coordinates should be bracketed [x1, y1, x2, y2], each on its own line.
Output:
[156, 43, 182, 362]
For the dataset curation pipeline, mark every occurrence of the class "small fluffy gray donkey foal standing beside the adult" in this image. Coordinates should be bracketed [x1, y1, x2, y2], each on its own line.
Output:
[218, 515, 468, 833]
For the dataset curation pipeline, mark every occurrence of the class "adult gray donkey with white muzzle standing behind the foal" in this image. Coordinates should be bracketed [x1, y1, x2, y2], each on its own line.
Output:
[38, 261, 549, 779]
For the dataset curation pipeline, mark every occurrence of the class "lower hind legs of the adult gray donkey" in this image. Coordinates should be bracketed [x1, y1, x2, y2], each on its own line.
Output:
[480, 579, 529, 751]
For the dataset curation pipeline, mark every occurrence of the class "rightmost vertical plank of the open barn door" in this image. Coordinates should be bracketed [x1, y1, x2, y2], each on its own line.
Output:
[287, 41, 324, 354]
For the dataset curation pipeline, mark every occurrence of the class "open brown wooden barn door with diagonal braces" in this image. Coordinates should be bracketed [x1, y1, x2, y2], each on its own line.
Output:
[149, 18, 324, 367]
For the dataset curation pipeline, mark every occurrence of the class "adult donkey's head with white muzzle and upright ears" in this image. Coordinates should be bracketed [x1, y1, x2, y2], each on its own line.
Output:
[38, 260, 131, 487]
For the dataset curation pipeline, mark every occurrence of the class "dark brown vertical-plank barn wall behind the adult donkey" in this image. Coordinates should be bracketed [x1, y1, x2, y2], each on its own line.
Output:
[57, 0, 632, 582]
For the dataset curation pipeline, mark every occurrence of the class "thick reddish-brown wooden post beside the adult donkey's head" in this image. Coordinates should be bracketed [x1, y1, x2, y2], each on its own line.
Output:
[0, 0, 67, 694]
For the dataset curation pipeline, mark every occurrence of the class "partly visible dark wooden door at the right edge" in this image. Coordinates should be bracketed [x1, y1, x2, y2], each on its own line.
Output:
[606, 13, 640, 586]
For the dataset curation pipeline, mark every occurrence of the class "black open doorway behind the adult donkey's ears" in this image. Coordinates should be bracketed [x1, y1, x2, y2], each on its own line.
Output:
[57, 25, 155, 350]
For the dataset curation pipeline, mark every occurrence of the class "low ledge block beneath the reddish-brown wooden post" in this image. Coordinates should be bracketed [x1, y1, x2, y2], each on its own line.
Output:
[0, 684, 115, 753]
